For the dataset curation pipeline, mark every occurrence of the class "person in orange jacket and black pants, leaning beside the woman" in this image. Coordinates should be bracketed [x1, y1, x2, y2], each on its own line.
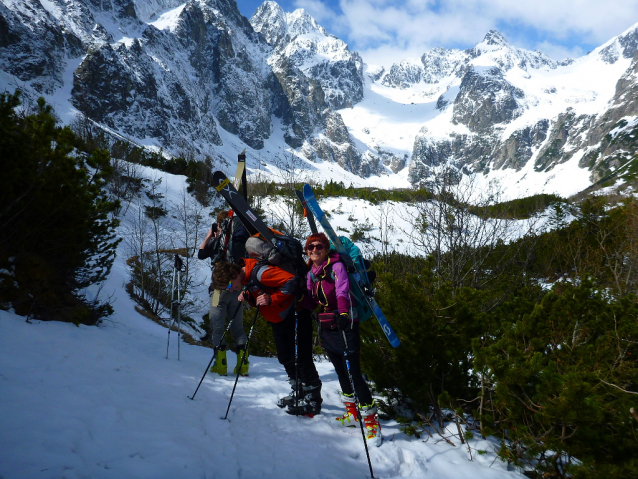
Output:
[213, 258, 323, 417]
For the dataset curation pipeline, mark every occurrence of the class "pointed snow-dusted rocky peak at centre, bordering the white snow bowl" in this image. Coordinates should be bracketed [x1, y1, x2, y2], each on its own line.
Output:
[250, 2, 378, 178]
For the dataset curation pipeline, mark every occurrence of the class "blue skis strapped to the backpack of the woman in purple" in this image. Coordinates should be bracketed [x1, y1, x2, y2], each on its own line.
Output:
[303, 184, 401, 348]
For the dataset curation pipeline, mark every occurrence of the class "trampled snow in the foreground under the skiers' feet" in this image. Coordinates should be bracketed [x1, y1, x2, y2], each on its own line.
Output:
[0, 278, 521, 479]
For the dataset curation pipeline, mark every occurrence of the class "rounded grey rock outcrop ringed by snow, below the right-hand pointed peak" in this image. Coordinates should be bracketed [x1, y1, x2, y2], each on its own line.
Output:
[452, 67, 524, 133]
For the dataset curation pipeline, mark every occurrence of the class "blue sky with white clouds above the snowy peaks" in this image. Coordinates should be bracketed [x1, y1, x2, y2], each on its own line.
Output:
[237, 0, 638, 66]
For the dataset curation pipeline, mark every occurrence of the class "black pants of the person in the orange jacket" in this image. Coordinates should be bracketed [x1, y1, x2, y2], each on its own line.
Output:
[270, 310, 321, 386]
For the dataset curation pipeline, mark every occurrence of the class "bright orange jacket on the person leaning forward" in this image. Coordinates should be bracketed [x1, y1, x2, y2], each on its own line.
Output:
[243, 258, 299, 323]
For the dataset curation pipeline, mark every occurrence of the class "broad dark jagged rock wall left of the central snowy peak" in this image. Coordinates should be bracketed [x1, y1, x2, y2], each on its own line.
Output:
[72, 0, 272, 150]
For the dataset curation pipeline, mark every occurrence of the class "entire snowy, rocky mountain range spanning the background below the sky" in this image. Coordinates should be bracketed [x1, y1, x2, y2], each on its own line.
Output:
[0, 0, 638, 196]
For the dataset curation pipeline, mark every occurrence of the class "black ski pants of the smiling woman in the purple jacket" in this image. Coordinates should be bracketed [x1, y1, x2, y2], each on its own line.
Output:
[321, 322, 372, 406]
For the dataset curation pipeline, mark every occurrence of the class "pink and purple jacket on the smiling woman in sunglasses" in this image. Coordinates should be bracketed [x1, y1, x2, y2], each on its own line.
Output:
[306, 253, 350, 314]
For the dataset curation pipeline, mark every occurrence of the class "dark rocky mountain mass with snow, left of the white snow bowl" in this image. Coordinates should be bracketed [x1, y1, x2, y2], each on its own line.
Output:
[0, 0, 372, 173]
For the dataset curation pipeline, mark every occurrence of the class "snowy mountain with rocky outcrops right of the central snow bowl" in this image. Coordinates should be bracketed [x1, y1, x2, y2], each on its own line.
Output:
[364, 25, 638, 192]
